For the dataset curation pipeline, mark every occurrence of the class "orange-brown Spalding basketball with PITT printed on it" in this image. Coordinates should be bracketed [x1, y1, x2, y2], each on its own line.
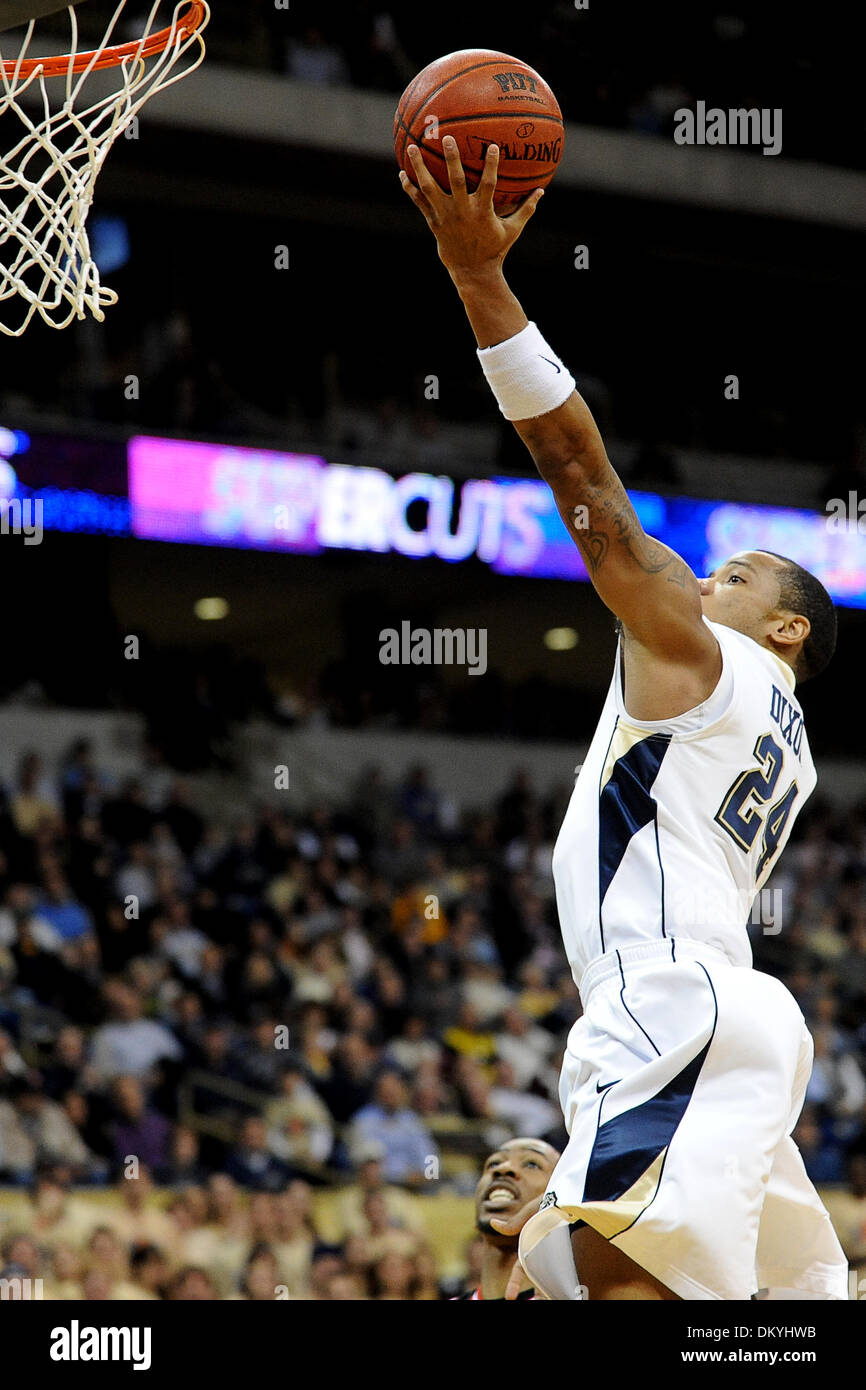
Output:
[393, 49, 564, 214]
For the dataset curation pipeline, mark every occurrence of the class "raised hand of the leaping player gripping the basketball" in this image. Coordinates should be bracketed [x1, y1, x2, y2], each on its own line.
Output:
[400, 135, 544, 278]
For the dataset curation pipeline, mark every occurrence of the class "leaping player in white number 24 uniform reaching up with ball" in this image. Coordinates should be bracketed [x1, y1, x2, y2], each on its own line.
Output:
[400, 138, 847, 1300]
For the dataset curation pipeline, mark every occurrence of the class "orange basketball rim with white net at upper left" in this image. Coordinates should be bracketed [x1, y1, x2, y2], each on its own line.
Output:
[0, 0, 210, 338]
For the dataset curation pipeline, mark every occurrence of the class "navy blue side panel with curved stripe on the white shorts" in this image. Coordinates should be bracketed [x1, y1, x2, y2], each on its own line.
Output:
[582, 962, 719, 1202]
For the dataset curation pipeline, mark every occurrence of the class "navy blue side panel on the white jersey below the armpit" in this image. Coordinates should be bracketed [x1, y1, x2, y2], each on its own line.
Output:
[598, 717, 673, 951]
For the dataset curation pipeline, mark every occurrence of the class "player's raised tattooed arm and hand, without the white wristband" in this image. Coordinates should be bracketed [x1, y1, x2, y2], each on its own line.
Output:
[400, 136, 720, 678]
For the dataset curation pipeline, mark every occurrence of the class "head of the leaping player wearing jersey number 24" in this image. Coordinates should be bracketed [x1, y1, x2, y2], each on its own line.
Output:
[701, 550, 835, 681]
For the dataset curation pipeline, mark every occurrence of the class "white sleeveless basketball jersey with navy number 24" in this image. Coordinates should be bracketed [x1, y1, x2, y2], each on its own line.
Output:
[553, 619, 816, 983]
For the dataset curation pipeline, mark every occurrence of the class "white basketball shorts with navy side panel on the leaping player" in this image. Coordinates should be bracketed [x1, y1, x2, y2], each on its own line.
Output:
[542, 938, 848, 1300]
